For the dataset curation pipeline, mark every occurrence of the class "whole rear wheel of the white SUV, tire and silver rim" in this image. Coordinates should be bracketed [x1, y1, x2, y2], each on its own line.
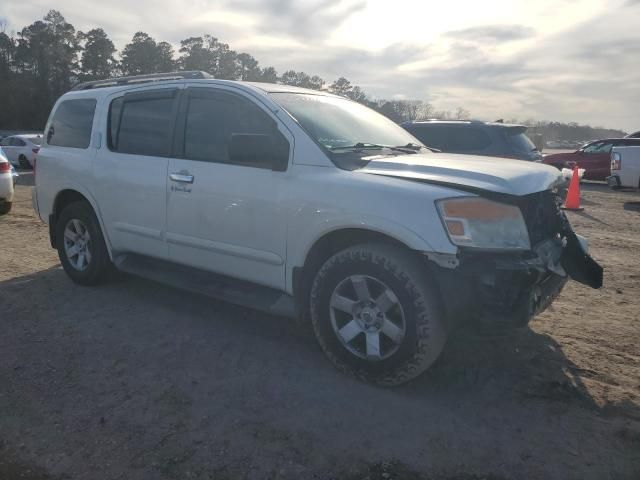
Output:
[56, 202, 112, 285]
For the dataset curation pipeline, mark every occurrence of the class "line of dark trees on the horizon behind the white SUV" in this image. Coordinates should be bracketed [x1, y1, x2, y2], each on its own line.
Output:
[0, 10, 623, 139]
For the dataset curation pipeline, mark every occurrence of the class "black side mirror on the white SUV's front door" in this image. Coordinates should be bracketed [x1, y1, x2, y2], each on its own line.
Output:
[229, 132, 289, 172]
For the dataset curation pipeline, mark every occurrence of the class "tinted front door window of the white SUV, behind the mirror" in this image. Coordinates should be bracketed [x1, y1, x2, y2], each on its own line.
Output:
[184, 89, 288, 168]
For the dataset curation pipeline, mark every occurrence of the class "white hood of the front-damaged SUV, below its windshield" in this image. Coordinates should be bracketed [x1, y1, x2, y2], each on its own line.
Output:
[357, 153, 562, 196]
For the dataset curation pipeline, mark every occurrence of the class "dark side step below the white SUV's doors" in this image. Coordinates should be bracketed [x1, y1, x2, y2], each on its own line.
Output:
[115, 254, 296, 318]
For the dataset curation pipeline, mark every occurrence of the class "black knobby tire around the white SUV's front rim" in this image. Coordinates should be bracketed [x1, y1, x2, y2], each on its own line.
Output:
[310, 244, 447, 386]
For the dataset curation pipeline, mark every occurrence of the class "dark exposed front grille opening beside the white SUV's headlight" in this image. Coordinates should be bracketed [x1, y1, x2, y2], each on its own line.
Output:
[518, 190, 563, 246]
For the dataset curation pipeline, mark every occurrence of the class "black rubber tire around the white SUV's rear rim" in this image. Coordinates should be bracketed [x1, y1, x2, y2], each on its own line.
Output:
[56, 202, 113, 286]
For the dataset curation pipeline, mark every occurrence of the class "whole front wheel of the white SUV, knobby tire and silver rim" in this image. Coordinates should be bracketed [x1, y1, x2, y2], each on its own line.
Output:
[310, 244, 446, 386]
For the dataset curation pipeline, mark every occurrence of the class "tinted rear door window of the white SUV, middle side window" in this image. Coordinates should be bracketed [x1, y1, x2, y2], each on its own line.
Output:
[108, 89, 176, 156]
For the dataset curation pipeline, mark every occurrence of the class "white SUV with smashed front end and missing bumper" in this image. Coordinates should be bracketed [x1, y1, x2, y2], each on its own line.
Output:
[34, 72, 602, 385]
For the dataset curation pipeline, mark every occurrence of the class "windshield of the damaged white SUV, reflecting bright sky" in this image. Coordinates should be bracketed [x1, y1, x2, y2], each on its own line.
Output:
[271, 93, 420, 150]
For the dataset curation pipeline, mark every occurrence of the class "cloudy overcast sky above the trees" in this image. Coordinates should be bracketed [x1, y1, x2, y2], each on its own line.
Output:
[0, 0, 640, 131]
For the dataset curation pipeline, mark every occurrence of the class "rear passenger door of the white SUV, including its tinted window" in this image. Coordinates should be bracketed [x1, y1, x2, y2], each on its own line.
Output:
[94, 86, 180, 259]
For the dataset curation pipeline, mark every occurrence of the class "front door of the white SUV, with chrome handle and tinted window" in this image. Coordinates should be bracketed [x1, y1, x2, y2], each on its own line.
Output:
[167, 87, 293, 289]
